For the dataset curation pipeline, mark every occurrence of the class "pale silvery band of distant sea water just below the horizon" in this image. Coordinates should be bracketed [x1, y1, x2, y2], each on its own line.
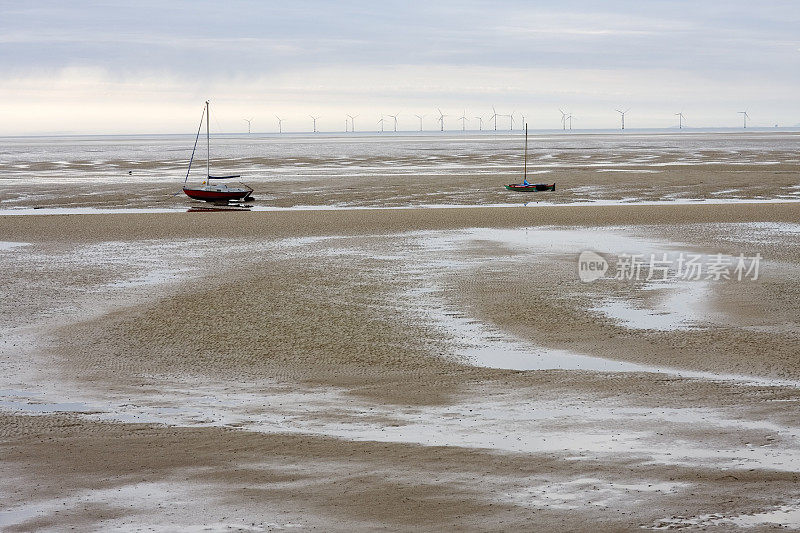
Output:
[0, 128, 800, 172]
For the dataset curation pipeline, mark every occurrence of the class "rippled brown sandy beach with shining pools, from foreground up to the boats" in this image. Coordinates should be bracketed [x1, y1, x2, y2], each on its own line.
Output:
[0, 132, 800, 531]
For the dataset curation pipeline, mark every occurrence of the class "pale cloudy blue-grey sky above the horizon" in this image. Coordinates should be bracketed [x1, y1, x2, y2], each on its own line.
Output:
[0, 0, 800, 135]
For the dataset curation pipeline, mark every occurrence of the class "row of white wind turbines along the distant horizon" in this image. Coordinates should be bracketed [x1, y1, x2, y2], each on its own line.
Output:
[260, 106, 750, 133]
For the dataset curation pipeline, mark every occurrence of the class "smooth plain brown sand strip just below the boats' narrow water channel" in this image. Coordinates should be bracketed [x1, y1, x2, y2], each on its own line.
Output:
[0, 203, 800, 242]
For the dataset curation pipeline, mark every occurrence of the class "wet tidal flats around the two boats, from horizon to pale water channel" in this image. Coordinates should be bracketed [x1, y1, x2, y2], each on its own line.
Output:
[0, 132, 800, 209]
